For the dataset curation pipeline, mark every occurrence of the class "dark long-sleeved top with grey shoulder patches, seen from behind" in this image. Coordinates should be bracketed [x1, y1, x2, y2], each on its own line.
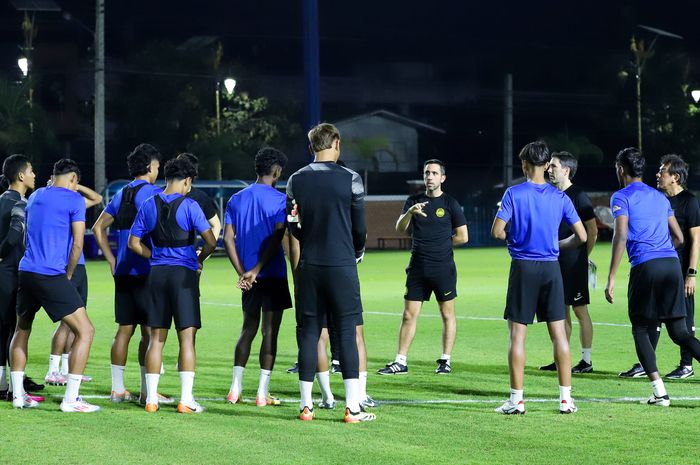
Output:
[287, 162, 367, 266]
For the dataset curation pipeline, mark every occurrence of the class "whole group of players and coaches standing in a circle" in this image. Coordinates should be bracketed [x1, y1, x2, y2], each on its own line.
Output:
[0, 123, 700, 423]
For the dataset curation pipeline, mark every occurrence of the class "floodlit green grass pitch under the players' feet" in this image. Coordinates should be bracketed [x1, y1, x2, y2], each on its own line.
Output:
[0, 244, 700, 464]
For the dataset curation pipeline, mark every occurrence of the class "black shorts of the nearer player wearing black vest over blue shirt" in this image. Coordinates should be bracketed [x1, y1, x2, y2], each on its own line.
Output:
[146, 265, 202, 329]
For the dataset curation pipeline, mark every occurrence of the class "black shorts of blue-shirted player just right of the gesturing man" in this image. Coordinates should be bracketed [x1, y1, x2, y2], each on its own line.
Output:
[503, 260, 566, 325]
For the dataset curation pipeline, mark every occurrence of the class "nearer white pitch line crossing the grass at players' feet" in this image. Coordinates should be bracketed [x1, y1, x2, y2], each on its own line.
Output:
[51, 394, 700, 405]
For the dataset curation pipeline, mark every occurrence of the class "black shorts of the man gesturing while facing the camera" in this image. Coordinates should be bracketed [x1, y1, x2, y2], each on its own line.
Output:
[403, 261, 457, 302]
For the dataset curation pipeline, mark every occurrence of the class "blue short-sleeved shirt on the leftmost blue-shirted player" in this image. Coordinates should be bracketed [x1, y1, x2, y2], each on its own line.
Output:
[19, 186, 85, 276]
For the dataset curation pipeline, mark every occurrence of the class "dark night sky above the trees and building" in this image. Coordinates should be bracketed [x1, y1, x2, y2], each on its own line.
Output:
[0, 0, 700, 190]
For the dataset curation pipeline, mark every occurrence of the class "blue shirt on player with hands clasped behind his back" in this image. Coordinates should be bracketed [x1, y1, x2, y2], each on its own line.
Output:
[225, 183, 287, 278]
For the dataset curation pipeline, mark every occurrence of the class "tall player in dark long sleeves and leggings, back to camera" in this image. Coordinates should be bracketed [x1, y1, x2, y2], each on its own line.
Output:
[287, 123, 375, 423]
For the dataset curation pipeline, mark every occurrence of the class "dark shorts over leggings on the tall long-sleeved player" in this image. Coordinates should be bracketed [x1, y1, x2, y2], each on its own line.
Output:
[296, 262, 362, 322]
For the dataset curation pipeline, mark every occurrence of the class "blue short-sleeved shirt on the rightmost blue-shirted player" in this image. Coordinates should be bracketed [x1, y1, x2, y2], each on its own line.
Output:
[610, 182, 678, 266]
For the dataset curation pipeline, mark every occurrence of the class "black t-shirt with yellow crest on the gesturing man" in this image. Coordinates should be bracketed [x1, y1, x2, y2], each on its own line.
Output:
[401, 192, 467, 266]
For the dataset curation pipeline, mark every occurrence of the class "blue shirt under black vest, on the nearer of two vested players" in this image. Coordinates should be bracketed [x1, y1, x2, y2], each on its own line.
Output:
[129, 192, 211, 271]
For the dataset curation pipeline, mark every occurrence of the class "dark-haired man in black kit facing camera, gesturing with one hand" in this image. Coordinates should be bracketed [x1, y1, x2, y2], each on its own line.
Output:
[377, 159, 469, 375]
